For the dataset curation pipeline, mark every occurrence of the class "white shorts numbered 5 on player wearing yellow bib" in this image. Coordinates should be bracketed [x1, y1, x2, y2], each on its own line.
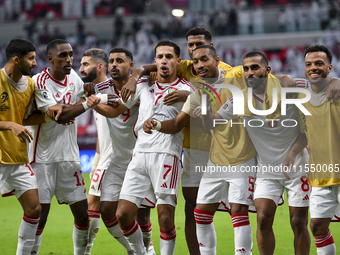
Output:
[197, 159, 256, 207]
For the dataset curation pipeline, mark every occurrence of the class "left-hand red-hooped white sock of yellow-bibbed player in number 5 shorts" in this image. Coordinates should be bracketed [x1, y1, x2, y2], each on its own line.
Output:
[194, 209, 217, 255]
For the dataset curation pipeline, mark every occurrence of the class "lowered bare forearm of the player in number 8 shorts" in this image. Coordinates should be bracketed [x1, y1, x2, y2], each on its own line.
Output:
[282, 133, 307, 179]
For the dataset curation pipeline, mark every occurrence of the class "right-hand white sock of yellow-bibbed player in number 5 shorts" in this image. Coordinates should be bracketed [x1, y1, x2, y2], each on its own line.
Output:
[231, 213, 253, 255]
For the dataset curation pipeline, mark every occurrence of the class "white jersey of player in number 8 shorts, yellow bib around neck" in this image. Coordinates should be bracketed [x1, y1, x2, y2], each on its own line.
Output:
[217, 94, 308, 178]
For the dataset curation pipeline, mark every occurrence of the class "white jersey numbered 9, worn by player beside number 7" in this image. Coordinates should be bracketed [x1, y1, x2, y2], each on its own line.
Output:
[96, 79, 138, 164]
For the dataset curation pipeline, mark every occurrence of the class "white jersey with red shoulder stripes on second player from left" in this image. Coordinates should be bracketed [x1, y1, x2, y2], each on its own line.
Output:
[29, 68, 84, 163]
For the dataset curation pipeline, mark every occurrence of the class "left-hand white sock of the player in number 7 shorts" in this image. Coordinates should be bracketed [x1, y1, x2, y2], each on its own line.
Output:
[121, 220, 146, 255]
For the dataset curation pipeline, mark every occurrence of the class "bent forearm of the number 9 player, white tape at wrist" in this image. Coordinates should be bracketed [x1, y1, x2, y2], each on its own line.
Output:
[87, 95, 129, 118]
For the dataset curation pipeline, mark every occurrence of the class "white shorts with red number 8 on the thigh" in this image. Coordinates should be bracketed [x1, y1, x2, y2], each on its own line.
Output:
[254, 175, 311, 207]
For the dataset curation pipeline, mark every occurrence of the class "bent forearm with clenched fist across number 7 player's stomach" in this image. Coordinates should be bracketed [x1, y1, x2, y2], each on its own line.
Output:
[143, 111, 190, 134]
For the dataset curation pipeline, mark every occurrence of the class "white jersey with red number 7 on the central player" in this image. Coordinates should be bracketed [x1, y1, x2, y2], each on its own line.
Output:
[124, 77, 194, 158]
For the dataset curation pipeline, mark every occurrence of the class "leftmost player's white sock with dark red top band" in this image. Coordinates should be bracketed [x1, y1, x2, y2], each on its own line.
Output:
[16, 214, 40, 255]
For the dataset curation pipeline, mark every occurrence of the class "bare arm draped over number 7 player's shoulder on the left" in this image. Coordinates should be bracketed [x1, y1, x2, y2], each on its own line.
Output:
[121, 65, 157, 102]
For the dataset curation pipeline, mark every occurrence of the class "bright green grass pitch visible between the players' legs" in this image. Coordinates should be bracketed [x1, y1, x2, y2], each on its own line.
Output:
[0, 174, 340, 255]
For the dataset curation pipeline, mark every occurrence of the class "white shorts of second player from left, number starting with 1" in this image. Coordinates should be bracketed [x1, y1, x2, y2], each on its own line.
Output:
[32, 161, 87, 205]
